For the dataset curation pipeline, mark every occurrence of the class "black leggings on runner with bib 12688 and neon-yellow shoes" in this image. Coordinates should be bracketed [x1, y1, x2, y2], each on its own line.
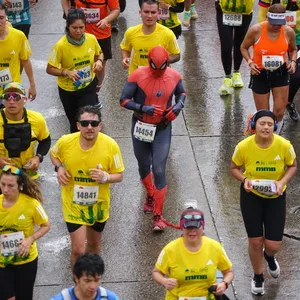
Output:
[216, 8, 252, 75]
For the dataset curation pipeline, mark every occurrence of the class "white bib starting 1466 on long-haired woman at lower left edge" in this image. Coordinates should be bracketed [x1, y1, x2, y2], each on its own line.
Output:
[0, 231, 24, 256]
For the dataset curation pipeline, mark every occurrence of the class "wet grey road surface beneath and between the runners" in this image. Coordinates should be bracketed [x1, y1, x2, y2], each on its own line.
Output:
[19, 0, 300, 300]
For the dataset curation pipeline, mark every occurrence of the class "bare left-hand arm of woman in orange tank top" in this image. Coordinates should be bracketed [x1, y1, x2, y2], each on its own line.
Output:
[240, 24, 261, 75]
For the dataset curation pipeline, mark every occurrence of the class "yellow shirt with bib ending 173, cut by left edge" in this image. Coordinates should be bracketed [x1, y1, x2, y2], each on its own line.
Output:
[0, 26, 31, 95]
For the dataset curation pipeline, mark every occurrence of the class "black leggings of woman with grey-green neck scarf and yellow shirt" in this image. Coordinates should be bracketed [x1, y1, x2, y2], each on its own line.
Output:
[58, 76, 98, 133]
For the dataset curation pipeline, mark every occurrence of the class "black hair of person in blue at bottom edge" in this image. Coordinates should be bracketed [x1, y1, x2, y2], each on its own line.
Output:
[73, 253, 104, 279]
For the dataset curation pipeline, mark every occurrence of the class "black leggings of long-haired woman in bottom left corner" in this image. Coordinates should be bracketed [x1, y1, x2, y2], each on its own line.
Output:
[0, 258, 38, 300]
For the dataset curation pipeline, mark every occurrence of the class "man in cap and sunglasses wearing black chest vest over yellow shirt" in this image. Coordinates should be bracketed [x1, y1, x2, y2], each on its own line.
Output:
[0, 82, 51, 179]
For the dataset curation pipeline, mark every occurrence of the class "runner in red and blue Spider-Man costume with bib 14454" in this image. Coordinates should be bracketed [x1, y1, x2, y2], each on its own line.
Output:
[120, 46, 186, 231]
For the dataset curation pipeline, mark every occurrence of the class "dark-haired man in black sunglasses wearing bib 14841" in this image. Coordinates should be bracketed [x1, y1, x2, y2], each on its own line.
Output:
[50, 106, 124, 265]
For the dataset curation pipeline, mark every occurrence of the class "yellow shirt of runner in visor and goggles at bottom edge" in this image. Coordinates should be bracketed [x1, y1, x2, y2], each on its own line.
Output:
[155, 236, 232, 300]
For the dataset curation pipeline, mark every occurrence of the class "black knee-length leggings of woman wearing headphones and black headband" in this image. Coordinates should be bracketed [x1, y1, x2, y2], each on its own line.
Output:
[240, 185, 286, 241]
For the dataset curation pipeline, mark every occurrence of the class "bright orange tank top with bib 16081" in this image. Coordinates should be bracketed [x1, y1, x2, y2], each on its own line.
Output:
[253, 21, 288, 70]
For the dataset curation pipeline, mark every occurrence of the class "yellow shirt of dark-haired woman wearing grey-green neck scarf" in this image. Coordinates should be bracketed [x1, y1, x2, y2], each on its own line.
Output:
[48, 33, 102, 91]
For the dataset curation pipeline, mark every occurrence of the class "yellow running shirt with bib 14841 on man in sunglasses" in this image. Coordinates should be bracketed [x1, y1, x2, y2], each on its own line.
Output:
[50, 132, 124, 225]
